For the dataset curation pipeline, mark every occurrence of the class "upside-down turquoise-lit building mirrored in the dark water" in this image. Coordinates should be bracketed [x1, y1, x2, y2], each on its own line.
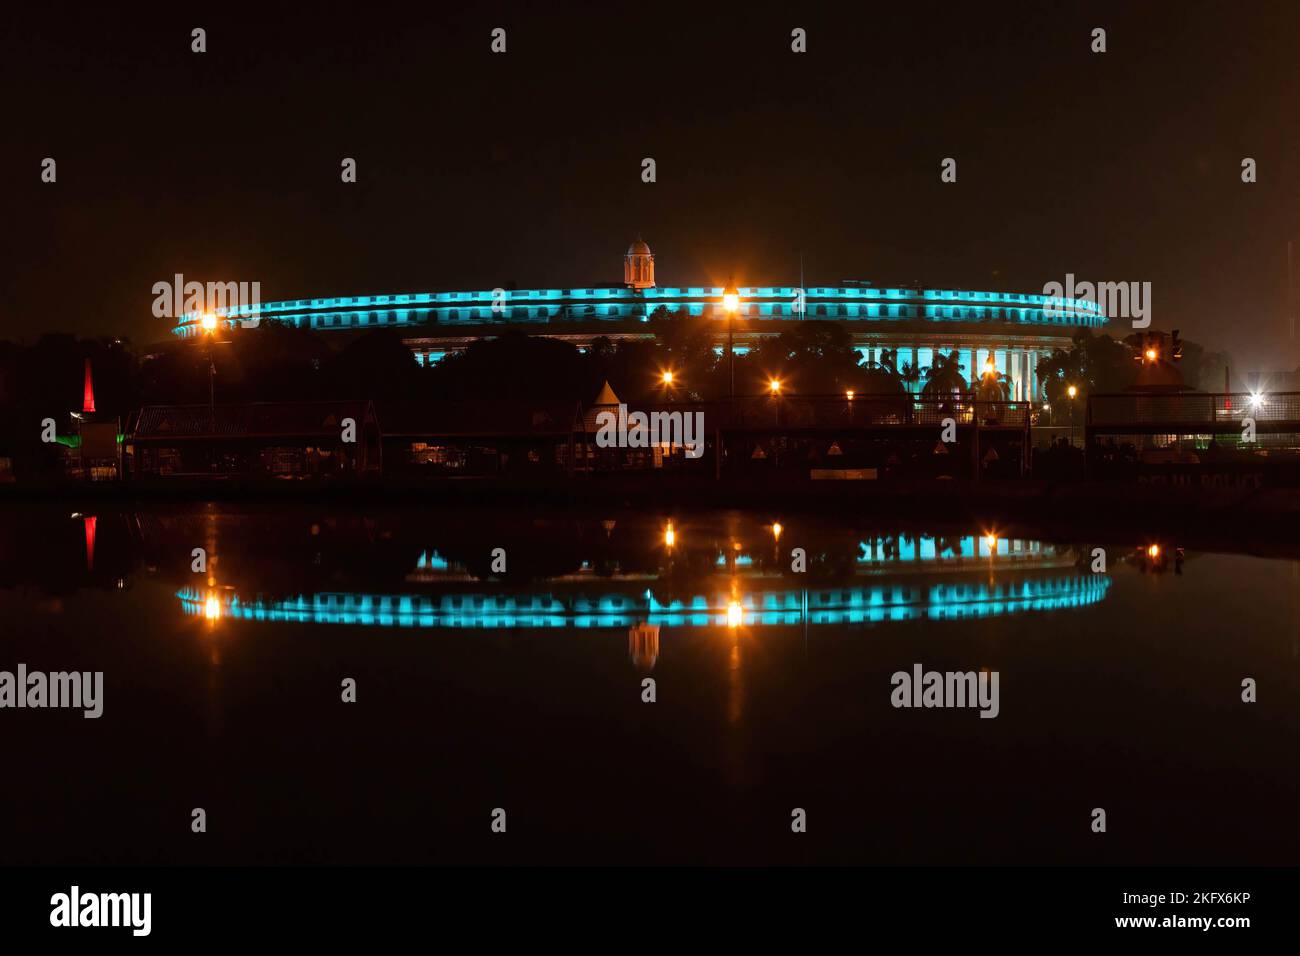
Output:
[177, 533, 1110, 634]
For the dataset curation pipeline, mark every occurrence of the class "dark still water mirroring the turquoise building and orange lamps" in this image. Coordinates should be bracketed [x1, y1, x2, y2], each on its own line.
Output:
[0, 505, 1300, 864]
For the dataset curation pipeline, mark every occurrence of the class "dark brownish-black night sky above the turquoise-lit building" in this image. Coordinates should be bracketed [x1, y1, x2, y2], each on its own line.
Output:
[0, 0, 1300, 368]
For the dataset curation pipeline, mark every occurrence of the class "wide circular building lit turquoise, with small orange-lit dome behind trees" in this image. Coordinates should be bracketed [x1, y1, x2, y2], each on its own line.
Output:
[173, 239, 1106, 401]
